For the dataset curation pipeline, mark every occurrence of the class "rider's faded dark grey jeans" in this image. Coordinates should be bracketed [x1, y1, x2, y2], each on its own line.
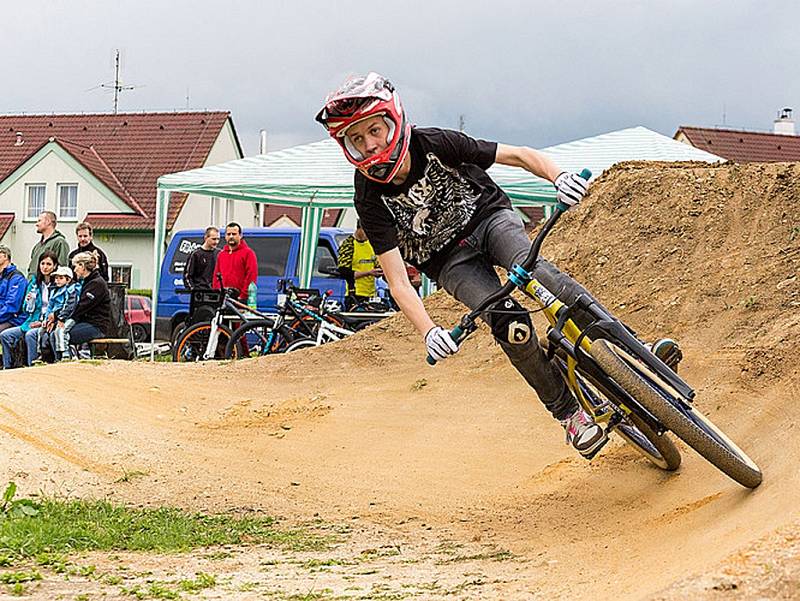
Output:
[438, 209, 588, 419]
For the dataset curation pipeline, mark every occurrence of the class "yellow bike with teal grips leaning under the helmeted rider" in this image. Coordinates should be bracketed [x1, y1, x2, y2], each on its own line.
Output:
[427, 170, 763, 488]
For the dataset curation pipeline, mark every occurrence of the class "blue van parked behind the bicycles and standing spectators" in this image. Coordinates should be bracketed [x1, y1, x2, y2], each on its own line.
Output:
[156, 227, 352, 340]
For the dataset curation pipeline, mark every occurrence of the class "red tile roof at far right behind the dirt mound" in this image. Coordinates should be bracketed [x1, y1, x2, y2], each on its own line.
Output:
[673, 126, 800, 163]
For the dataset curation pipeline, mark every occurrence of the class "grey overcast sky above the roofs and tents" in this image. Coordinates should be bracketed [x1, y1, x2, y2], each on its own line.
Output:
[0, 0, 800, 154]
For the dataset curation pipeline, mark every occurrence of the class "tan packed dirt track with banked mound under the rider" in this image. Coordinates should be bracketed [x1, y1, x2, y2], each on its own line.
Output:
[0, 163, 800, 600]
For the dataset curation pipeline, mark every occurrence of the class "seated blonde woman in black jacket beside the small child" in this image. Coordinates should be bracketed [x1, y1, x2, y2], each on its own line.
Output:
[70, 252, 111, 346]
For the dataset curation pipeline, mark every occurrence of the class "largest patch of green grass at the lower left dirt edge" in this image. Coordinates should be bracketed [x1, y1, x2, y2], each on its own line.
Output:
[0, 482, 332, 568]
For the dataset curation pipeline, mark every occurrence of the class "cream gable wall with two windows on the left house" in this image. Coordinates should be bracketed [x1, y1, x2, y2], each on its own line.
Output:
[0, 151, 133, 271]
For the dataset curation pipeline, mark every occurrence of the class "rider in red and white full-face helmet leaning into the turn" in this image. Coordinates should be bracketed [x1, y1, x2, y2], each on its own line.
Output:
[316, 73, 680, 458]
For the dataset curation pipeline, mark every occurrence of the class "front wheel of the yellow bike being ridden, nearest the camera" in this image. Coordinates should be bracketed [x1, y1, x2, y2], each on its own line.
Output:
[591, 340, 763, 488]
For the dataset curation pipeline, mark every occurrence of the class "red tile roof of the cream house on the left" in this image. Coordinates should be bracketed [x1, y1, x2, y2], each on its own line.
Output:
[0, 111, 241, 230]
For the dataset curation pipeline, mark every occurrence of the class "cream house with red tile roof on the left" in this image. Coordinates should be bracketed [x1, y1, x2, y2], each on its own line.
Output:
[0, 111, 259, 288]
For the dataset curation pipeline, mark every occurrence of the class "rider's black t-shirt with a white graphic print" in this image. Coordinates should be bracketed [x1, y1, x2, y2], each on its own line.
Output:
[354, 128, 511, 279]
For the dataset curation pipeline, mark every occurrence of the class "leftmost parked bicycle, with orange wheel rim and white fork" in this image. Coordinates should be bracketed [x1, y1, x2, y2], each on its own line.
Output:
[172, 288, 271, 363]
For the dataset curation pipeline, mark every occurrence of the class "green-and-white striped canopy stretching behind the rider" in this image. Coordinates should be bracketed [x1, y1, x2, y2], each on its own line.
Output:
[153, 127, 722, 346]
